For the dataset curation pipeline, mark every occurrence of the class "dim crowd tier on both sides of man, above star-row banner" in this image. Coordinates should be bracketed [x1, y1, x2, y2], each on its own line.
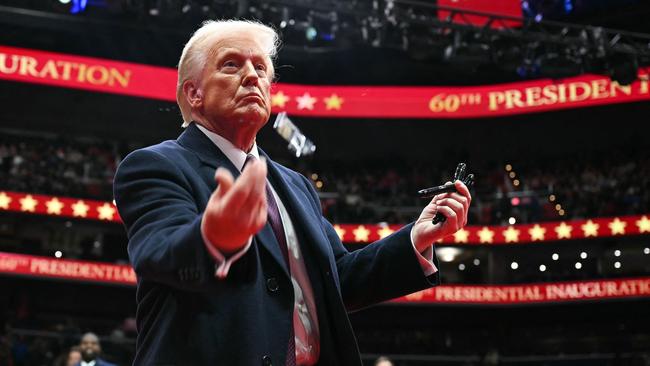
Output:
[0, 133, 650, 225]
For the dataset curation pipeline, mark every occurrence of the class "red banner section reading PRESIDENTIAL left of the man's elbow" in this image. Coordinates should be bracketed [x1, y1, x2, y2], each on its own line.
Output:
[0, 252, 136, 285]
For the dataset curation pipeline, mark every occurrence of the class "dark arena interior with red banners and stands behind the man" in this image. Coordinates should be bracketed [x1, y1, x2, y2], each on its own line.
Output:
[0, 0, 650, 366]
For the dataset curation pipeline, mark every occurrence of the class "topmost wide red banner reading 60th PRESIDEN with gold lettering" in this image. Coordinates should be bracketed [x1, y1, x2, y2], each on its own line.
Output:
[0, 46, 650, 119]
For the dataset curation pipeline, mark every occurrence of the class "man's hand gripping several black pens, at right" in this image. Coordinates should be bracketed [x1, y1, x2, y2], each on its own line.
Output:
[411, 180, 472, 252]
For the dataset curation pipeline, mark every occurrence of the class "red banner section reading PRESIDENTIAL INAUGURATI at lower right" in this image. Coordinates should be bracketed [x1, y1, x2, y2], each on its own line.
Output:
[393, 277, 650, 304]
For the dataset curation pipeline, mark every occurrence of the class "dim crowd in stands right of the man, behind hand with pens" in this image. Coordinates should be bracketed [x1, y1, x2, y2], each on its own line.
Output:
[305, 150, 650, 225]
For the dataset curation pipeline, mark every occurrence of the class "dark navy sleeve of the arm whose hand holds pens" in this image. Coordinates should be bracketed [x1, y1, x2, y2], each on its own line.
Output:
[296, 173, 440, 311]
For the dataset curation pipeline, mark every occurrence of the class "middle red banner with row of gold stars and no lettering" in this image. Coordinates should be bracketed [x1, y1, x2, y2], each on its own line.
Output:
[0, 191, 650, 245]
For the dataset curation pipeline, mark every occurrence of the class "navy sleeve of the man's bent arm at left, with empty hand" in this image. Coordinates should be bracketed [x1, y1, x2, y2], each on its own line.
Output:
[114, 150, 214, 291]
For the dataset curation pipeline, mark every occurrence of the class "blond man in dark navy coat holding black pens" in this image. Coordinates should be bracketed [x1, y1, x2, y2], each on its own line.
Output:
[114, 21, 471, 365]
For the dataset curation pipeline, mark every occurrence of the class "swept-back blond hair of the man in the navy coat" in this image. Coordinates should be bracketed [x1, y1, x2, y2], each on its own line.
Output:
[176, 20, 280, 127]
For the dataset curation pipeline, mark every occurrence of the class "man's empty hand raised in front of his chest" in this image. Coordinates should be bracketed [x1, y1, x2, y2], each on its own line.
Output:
[201, 160, 267, 254]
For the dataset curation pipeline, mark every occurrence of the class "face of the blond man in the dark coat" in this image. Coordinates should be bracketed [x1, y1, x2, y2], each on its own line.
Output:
[198, 33, 273, 130]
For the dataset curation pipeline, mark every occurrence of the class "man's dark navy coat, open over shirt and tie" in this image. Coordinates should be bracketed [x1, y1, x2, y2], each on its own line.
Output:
[114, 124, 438, 366]
